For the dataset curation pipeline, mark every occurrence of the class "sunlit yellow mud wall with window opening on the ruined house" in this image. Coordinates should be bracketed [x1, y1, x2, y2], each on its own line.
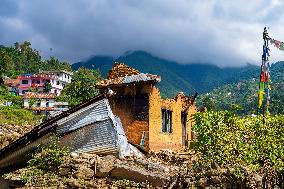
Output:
[149, 87, 195, 151]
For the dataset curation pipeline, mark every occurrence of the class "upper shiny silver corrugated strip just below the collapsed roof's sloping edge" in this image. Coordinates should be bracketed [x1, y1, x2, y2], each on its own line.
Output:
[56, 100, 108, 134]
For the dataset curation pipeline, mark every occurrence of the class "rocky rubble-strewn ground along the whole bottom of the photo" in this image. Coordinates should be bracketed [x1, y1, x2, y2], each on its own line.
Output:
[0, 150, 281, 189]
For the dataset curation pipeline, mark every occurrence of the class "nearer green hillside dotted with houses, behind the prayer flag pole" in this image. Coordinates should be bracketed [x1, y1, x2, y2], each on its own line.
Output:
[198, 62, 284, 114]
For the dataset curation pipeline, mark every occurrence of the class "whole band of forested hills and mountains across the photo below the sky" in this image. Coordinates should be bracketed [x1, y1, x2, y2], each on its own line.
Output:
[0, 42, 284, 113]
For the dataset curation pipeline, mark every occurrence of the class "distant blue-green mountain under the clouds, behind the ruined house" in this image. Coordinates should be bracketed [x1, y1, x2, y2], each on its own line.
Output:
[72, 51, 258, 97]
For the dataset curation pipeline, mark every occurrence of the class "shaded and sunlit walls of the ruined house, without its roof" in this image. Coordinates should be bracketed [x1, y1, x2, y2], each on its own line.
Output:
[106, 84, 196, 151]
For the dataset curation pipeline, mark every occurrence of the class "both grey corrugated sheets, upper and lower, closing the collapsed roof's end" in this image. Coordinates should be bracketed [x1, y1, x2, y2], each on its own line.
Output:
[56, 99, 118, 153]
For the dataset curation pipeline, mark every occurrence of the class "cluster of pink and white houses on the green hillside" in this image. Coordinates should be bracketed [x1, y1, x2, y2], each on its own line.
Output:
[3, 70, 73, 113]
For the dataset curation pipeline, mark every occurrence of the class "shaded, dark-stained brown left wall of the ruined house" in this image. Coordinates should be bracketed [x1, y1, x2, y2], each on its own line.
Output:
[110, 85, 150, 150]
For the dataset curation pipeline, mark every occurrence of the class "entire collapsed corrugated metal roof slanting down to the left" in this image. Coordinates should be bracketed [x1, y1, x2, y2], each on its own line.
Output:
[0, 97, 129, 173]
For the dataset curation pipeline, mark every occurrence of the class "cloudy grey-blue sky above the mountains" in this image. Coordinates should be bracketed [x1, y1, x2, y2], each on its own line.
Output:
[0, 0, 284, 66]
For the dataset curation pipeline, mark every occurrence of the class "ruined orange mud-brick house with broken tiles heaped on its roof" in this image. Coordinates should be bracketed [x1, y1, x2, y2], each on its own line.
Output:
[97, 63, 196, 151]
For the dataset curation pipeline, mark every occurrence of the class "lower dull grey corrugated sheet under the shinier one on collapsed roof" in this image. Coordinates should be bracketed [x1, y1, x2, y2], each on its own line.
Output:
[61, 119, 118, 154]
